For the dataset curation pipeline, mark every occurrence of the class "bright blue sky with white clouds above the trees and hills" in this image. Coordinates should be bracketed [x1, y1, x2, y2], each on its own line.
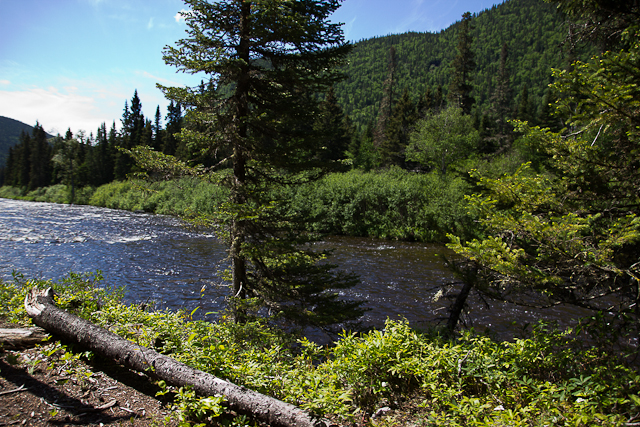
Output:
[0, 0, 502, 134]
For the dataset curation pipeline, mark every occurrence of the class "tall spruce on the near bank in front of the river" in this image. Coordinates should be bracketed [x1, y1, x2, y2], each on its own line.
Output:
[154, 0, 361, 327]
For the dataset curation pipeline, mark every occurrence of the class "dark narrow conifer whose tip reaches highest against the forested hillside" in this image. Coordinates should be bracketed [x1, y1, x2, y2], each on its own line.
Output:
[448, 12, 476, 114]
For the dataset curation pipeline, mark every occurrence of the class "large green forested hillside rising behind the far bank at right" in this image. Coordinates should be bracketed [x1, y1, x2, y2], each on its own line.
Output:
[336, 0, 592, 126]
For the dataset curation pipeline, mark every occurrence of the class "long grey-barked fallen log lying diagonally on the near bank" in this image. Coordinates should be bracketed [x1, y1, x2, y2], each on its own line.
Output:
[24, 288, 331, 427]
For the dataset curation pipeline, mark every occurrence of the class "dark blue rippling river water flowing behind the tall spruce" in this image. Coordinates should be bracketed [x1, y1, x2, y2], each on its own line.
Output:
[0, 199, 578, 338]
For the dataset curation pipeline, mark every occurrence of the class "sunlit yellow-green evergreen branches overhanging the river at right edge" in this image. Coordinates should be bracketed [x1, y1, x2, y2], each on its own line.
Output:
[449, 5, 640, 332]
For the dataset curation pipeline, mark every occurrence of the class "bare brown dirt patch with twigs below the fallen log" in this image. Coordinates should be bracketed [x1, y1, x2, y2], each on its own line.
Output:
[0, 325, 178, 427]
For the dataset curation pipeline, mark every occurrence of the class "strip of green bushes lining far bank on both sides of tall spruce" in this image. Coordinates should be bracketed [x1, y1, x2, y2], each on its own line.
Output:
[0, 169, 475, 243]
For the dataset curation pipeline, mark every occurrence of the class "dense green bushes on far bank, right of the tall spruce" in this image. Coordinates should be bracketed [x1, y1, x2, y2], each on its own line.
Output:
[289, 168, 472, 242]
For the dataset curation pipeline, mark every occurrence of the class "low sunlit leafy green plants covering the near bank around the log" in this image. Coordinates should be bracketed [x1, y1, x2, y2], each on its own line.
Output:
[0, 276, 640, 427]
